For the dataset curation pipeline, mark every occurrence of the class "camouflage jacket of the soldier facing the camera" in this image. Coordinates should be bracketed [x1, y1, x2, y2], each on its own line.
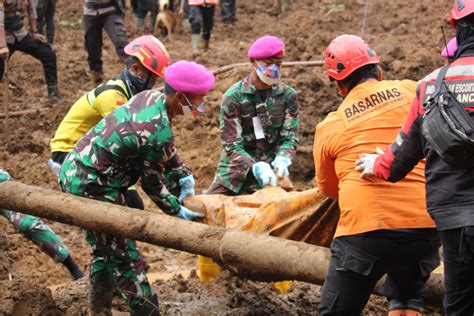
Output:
[214, 76, 299, 194]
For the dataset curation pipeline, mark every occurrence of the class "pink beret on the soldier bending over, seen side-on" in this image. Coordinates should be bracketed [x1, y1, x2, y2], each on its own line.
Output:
[165, 60, 216, 95]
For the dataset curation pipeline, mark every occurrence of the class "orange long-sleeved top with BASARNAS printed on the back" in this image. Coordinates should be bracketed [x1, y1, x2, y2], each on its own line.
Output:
[313, 80, 435, 237]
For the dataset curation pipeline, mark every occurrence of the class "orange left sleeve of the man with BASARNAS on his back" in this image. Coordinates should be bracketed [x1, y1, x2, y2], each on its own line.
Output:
[313, 124, 339, 200]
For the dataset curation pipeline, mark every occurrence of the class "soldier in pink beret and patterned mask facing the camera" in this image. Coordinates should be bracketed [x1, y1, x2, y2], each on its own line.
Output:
[207, 36, 299, 195]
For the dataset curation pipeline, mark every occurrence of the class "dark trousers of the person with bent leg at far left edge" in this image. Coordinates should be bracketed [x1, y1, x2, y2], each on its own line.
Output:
[0, 34, 58, 87]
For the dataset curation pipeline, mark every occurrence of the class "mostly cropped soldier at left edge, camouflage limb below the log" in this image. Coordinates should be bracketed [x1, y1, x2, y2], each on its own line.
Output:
[0, 168, 84, 280]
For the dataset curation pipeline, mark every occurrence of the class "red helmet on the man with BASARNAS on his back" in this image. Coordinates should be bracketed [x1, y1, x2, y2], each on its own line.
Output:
[326, 34, 379, 80]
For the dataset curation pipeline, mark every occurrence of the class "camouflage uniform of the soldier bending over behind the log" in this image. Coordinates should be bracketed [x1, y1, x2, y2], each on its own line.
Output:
[59, 90, 191, 309]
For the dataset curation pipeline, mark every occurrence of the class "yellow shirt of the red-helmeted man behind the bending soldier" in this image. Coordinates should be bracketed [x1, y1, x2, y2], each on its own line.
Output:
[50, 80, 130, 152]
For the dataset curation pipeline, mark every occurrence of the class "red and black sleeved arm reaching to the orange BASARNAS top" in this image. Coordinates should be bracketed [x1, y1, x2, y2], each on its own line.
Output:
[374, 89, 424, 182]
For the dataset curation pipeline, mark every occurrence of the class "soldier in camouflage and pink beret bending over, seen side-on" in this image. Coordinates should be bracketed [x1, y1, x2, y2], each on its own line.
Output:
[59, 61, 214, 315]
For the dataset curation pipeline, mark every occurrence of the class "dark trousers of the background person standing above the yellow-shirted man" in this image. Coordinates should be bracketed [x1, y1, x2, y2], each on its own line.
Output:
[83, 13, 128, 71]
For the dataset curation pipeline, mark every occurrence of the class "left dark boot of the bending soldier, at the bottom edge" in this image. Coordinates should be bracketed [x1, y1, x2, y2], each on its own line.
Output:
[89, 270, 115, 316]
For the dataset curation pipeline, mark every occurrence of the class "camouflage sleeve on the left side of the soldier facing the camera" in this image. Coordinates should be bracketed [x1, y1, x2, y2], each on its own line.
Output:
[220, 95, 255, 174]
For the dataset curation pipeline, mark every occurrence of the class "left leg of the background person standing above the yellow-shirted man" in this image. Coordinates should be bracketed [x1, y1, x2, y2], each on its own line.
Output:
[83, 15, 104, 84]
